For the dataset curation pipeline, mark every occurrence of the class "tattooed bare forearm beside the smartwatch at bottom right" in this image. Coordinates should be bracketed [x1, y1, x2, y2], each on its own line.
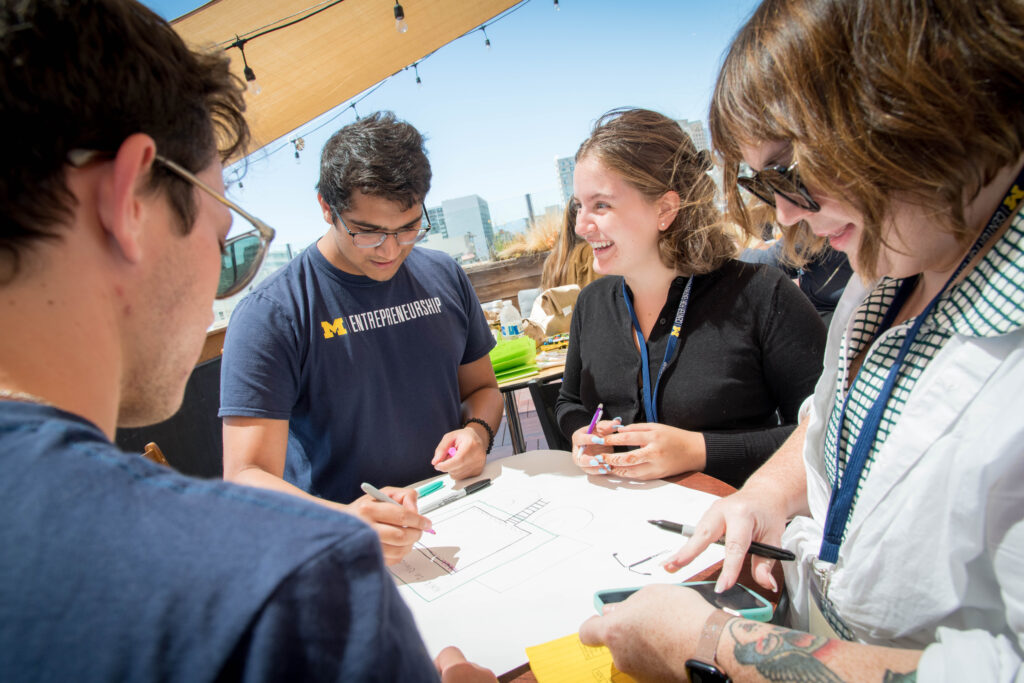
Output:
[716, 618, 921, 683]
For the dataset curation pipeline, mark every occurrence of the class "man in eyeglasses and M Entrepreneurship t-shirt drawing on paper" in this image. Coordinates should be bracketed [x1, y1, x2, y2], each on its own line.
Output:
[220, 113, 502, 564]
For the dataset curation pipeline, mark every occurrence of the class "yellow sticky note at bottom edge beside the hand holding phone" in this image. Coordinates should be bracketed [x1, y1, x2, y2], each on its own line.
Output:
[526, 633, 635, 683]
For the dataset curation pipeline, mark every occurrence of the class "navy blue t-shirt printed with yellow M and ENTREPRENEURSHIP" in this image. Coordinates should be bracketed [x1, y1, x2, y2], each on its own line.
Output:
[220, 245, 495, 503]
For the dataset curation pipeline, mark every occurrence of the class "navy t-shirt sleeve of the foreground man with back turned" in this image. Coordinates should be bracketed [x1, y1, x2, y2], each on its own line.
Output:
[219, 533, 438, 682]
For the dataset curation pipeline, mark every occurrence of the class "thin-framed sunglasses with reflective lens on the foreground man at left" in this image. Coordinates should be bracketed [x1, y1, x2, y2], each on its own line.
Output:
[68, 150, 274, 299]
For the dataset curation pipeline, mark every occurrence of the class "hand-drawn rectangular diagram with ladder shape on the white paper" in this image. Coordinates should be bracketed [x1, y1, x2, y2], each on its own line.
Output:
[391, 498, 589, 602]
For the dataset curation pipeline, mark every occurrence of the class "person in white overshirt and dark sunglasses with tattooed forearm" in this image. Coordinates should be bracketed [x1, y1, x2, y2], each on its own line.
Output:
[581, 0, 1024, 681]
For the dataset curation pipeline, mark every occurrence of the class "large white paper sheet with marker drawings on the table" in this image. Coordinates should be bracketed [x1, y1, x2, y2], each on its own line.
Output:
[391, 451, 723, 674]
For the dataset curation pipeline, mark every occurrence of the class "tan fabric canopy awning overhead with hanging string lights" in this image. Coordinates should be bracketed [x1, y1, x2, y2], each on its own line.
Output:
[172, 0, 517, 156]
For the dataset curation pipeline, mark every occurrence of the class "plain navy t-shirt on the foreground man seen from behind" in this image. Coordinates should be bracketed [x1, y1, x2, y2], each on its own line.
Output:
[0, 401, 437, 683]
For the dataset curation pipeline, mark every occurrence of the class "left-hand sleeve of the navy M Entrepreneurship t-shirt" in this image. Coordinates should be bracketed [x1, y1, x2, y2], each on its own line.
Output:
[218, 292, 301, 420]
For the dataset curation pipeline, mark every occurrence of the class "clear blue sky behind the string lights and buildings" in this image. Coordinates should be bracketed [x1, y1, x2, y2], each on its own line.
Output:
[145, 0, 757, 246]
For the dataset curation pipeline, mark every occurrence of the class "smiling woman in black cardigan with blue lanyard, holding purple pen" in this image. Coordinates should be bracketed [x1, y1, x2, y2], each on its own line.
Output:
[556, 109, 825, 486]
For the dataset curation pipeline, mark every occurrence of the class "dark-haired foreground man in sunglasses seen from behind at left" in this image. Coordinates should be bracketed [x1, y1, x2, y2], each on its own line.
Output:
[0, 0, 494, 681]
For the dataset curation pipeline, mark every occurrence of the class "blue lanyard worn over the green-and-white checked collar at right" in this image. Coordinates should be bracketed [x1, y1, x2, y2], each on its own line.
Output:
[818, 169, 1024, 563]
